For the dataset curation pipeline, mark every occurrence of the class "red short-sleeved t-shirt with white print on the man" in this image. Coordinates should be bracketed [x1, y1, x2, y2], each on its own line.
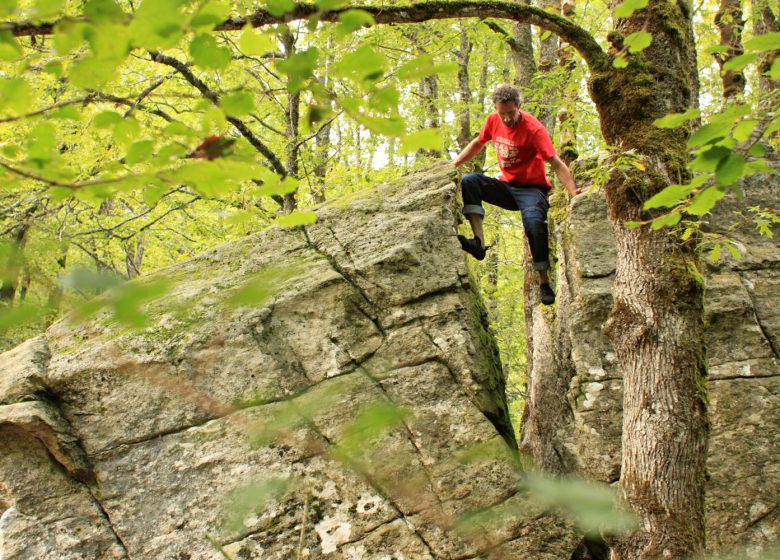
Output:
[479, 111, 555, 188]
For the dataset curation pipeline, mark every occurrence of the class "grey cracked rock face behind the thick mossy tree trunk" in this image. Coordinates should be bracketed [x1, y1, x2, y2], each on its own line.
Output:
[521, 165, 780, 551]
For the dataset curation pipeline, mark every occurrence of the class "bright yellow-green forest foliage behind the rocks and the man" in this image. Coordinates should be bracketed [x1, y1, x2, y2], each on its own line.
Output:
[0, 0, 780, 556]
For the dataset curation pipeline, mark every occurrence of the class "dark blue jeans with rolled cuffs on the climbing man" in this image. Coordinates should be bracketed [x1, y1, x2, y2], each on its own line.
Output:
[460, 173, 550, 270]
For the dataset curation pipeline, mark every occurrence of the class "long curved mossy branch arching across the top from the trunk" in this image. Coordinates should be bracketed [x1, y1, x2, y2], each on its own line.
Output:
[0, 0, 606, 72]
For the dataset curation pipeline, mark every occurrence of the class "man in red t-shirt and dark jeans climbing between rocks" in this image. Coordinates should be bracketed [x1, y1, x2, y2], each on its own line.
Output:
[453, 85, 580, 305]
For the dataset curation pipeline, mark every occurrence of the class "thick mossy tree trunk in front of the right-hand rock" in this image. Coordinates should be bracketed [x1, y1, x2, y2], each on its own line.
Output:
[591, 2, 707, 560]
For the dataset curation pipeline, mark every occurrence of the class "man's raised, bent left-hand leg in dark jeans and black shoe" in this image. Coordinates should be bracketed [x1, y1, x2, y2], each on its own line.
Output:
[458, 173, 518, 260]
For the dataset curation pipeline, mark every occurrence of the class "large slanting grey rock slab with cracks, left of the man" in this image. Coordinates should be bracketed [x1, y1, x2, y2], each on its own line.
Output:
[0, 165, 580, 560]
